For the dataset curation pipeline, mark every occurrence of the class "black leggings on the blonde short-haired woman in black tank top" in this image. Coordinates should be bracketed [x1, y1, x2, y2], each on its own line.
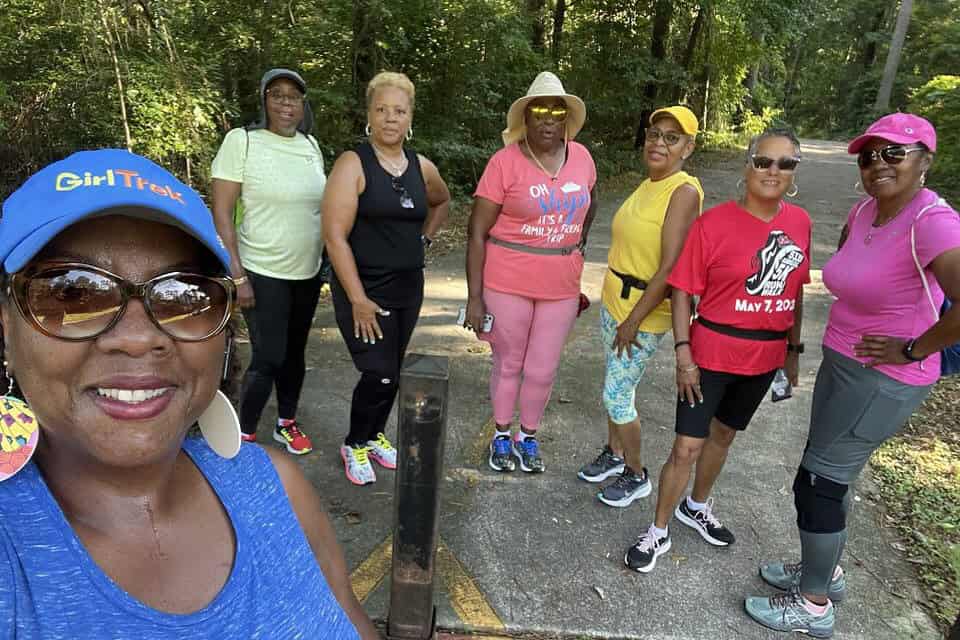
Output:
[331, 278, 423, 446]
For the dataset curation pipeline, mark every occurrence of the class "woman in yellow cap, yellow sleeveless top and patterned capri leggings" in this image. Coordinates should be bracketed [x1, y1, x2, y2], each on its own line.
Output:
[577, 106, 703, 507]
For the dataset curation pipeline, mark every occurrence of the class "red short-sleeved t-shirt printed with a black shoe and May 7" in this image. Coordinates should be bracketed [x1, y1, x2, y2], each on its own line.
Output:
[667, 201, 812, 375]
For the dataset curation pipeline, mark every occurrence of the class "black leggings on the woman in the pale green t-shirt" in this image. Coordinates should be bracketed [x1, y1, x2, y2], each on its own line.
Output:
[240, 271, 321, 433]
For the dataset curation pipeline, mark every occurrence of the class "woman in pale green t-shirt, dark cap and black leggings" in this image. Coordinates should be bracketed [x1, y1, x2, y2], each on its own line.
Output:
[211, 69, 326, 454]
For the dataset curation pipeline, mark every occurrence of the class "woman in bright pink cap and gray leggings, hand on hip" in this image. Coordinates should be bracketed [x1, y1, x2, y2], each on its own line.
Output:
[745, 113, 960, 638]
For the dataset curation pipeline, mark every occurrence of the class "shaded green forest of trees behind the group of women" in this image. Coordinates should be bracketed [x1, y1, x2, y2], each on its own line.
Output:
[0, 0, 960, 197]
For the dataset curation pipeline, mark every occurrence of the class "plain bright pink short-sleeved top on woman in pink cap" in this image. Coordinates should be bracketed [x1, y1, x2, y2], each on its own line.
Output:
[823, 189, 960, 386]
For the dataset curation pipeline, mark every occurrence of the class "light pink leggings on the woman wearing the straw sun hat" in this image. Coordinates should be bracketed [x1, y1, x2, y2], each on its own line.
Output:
[483, 289, 579, 430]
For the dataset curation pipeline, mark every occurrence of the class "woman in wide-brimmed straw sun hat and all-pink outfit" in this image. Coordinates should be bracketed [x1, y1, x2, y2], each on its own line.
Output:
[465, 71, 597, 473]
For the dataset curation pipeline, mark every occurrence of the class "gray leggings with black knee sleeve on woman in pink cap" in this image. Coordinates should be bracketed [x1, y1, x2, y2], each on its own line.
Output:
[794, 347, 932, 595]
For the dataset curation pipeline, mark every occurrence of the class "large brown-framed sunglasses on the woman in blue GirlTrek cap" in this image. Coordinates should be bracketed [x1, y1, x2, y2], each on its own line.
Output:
[10, 262, 236, 342]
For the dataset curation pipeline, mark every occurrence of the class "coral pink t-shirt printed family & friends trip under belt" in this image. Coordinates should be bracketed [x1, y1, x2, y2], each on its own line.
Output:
[474, 142, 597, 300]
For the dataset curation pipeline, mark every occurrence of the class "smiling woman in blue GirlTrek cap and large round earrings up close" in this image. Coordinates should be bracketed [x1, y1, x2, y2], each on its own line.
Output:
[0, 150, 377, 640]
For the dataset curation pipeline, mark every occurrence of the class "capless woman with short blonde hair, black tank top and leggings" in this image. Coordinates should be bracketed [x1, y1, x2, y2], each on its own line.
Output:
[322, 72, 450, 485]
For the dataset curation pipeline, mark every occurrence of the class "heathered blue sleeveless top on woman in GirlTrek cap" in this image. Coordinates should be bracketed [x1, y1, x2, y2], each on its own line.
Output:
[0, 438, 359, 640]
